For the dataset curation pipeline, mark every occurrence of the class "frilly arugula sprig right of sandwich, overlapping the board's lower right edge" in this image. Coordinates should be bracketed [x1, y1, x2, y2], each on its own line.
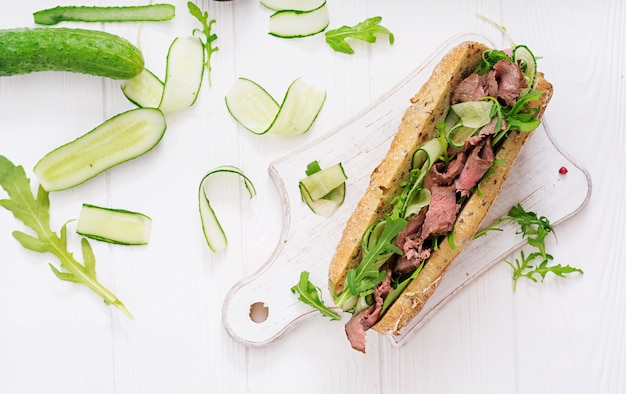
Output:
[474, 204, 583, 291]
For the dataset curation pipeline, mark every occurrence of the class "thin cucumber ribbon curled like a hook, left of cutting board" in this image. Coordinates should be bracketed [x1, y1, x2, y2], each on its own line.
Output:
[198, 165, 256, 252]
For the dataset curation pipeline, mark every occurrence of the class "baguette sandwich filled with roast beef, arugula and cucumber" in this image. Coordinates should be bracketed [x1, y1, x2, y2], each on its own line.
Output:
[329, 42, 552, 352]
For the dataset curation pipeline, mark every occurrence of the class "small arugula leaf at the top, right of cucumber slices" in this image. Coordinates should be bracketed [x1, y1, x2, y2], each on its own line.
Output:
[325, 16, 394, 54]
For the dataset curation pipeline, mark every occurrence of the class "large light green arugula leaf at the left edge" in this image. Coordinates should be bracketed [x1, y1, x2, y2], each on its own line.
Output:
[0, 155, 133, 319]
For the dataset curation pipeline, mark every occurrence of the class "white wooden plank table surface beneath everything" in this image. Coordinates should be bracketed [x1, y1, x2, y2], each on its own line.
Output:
[0, 0, 626, 394]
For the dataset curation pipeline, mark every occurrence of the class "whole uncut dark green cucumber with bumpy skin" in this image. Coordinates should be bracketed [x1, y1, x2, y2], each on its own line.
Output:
[0, 27, 144, 80]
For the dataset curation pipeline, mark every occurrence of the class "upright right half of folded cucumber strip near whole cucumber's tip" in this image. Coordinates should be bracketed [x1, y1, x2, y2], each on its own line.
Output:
[159, 36, 204, 113]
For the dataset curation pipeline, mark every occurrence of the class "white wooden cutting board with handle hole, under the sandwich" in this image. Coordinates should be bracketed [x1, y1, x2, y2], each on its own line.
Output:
[223, 35, 591, 346]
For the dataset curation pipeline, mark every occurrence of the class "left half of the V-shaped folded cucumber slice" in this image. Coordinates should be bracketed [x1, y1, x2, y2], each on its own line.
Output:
[226, 78, 280, 134]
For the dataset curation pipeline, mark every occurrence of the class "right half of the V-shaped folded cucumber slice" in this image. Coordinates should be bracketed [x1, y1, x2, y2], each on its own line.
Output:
[268, 78, 326, 136]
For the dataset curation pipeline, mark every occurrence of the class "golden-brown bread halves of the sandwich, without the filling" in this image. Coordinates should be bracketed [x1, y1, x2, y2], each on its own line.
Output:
[329, 41, 552, 335]
